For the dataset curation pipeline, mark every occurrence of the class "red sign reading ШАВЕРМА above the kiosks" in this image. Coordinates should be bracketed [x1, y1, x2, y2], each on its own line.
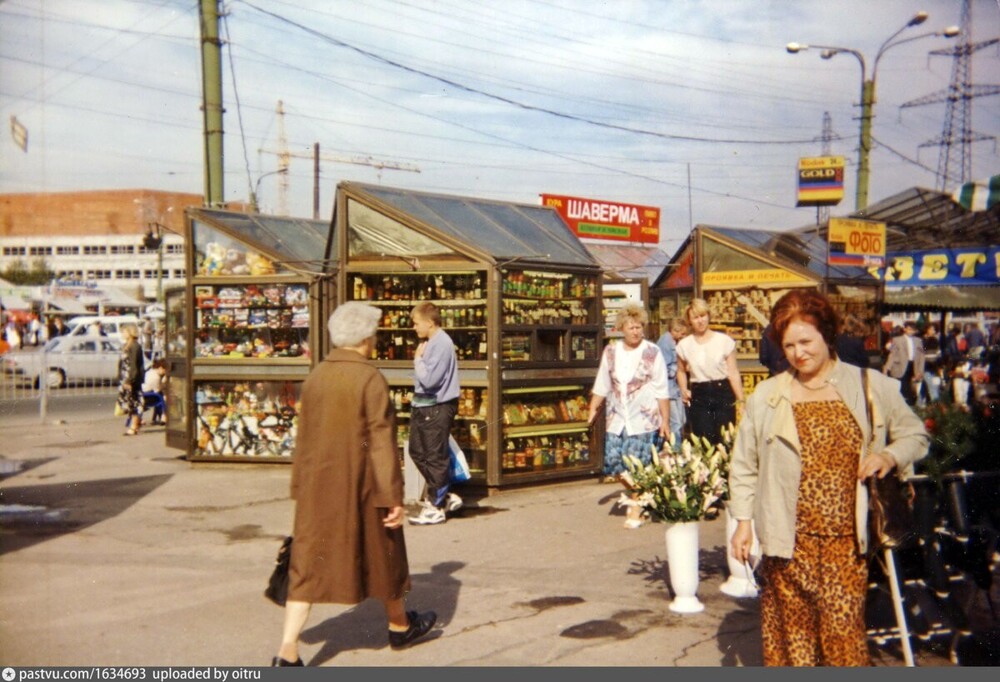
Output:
[541, 194, 660, 244]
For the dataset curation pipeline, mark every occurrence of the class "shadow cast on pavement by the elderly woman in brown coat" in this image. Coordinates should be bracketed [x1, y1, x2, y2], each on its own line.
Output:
[302, 561, 465, 667]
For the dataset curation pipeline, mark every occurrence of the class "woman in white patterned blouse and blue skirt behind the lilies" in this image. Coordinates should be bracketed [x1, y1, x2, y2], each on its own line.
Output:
[588, 304, 670, 528]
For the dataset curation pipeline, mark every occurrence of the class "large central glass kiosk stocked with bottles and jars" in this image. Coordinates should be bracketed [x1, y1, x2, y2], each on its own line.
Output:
[334, 182, 603, 487]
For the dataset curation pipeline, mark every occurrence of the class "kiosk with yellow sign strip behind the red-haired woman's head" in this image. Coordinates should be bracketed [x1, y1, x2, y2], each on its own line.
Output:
[649, 225, 879, 395]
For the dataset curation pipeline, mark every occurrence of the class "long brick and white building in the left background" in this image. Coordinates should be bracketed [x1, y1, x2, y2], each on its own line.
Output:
[0, 189, 203, 300]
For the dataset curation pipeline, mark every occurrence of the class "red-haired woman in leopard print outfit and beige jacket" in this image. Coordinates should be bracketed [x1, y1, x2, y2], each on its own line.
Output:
[729, 290, 929, 666]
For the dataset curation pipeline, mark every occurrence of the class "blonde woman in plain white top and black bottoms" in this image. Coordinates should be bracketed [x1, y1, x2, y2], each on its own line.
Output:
[677, 298, 743, 443]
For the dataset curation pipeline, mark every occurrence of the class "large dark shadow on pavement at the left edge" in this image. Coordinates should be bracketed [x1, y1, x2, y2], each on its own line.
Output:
[0, 474, 172, 555]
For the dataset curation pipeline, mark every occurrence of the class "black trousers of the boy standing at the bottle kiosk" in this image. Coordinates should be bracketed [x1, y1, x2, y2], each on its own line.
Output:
[410, 400, 458, 507]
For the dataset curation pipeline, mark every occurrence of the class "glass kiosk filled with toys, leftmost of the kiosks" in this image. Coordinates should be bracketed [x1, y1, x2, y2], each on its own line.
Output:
[176, 209, 336, 462]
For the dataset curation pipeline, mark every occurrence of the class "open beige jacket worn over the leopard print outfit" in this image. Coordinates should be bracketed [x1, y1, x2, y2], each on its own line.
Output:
[728, 360, 930, 559]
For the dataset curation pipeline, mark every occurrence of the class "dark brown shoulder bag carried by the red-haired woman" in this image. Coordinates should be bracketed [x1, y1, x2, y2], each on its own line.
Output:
[861, 369, 915, 555]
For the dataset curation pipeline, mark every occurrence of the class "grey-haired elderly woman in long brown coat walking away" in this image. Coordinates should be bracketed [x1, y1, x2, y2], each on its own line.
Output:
[271, 302, 437, 666]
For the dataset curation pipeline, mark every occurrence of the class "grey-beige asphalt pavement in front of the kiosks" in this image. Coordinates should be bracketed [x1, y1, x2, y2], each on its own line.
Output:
[0, 408, 984, 667]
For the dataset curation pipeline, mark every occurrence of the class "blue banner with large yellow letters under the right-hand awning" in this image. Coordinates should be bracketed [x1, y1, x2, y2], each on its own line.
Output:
[871, 246, 1000, 286]
